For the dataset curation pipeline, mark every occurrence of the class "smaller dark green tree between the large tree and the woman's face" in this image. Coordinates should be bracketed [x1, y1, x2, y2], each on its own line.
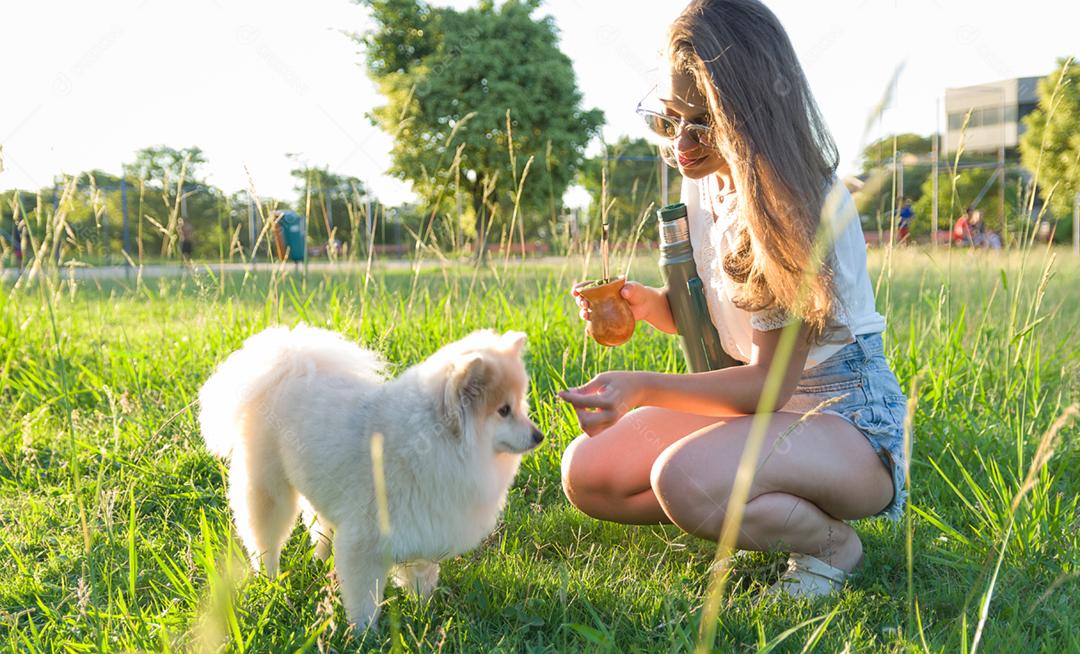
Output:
[578, 136, 683, 229]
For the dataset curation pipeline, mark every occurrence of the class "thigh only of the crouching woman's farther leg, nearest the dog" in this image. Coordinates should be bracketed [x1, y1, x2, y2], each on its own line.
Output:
[563, 407, 724, 500]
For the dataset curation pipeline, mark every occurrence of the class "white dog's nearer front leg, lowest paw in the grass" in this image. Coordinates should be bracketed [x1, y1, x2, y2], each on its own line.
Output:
[334, 528, 387, 630]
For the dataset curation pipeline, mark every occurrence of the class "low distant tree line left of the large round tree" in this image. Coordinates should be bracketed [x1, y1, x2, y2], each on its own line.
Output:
[0, 146, 421, 263]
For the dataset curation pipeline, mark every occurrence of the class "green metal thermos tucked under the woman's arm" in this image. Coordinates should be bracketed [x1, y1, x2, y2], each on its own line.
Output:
[657, 202, 739, 372]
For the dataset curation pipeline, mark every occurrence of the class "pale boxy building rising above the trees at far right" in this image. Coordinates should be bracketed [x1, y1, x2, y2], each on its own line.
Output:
[942, 77, 1040, 153]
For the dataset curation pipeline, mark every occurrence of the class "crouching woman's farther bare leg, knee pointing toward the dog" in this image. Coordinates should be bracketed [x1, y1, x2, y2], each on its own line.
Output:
[563, 407, 719, 524]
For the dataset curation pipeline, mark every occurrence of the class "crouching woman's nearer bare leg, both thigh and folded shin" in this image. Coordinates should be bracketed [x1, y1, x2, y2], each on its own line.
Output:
[650, 413, 893, 570]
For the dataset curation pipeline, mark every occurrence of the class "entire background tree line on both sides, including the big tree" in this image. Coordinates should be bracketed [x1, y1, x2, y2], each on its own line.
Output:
[6, 10, 1080, 259]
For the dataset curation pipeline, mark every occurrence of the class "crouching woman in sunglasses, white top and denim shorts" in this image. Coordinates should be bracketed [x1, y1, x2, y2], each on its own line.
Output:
[559, 0, 905, 596]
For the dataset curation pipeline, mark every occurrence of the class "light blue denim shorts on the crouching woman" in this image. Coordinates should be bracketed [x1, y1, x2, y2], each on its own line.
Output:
[783, 333, 907, 520]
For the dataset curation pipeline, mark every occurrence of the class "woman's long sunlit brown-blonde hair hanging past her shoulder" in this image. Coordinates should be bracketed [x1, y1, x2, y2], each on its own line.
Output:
[667, 0, 838, 340]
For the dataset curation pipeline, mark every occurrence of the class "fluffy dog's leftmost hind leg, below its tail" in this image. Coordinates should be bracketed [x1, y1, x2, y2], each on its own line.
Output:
[229, 451, 297, 578]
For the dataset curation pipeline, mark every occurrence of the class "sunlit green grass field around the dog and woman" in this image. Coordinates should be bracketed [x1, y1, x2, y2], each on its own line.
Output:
[0, 249, 1080, 652]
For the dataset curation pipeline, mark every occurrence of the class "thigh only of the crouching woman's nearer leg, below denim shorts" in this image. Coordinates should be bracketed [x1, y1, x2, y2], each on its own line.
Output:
[653, 412, 893, 520]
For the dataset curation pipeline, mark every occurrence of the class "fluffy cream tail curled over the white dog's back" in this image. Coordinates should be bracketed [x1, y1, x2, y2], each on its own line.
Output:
[199, 324, 386, 457]
